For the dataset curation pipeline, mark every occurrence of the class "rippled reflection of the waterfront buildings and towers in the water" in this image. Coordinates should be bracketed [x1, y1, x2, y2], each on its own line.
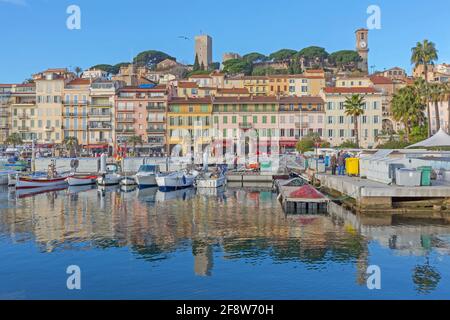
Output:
[0, 187, 450, 291]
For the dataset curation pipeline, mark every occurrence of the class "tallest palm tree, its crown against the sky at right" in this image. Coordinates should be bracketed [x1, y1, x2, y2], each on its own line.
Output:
[411, 40, 438, 136]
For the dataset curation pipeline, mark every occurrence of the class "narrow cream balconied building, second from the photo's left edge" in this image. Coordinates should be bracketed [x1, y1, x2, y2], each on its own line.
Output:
[10, 83, 37, 143]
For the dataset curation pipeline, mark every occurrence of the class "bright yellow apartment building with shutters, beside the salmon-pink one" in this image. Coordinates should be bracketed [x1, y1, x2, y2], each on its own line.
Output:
[167, 97, 212, 154]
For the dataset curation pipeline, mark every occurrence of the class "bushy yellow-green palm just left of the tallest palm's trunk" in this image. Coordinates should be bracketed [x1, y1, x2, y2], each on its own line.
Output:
[391, 86, 425, 141]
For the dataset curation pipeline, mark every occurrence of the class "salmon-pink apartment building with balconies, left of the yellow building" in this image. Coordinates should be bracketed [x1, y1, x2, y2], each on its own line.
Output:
[115, 85, 168, 155]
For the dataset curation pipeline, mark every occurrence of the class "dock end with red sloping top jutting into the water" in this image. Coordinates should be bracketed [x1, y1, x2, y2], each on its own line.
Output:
[278, 185, 330, 214]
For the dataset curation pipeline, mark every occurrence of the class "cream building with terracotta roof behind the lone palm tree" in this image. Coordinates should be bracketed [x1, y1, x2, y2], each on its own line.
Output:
[322, 87, 383, 148]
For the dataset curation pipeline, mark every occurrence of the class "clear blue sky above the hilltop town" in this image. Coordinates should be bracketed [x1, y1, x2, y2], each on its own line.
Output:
[0, 0, 450, 83]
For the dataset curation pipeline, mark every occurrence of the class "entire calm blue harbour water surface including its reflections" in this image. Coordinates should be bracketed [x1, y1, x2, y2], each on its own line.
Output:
[0, 187, 450, 299]
